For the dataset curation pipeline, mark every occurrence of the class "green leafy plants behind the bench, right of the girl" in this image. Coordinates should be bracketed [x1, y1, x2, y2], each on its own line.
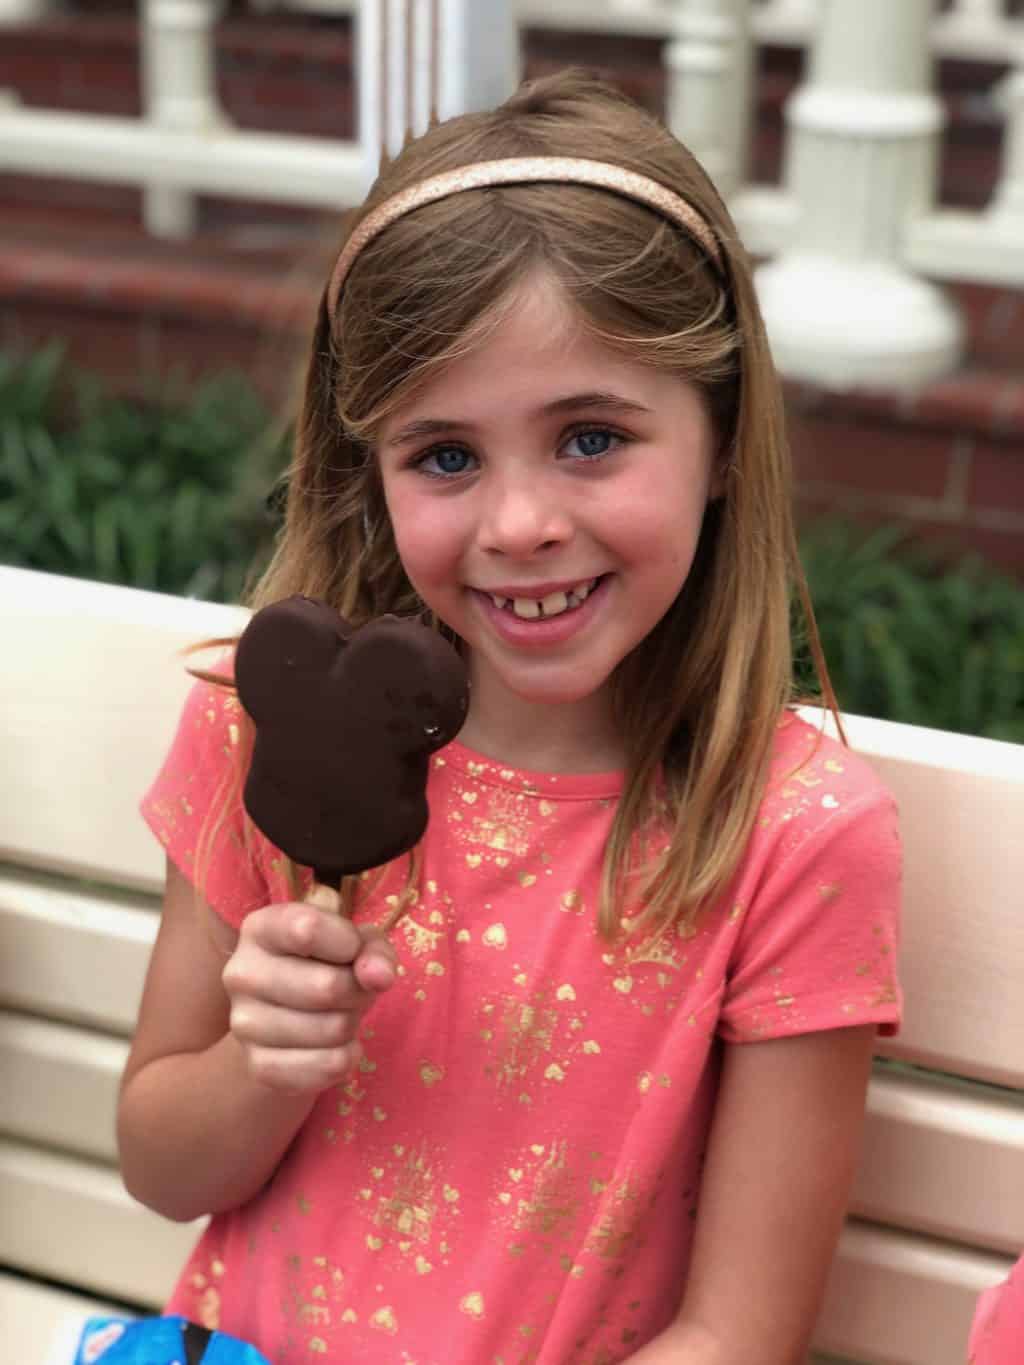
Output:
[799, 521, 1024, 741]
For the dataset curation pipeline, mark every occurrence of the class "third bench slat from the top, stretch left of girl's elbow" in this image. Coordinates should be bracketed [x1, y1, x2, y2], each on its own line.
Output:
[0, 1010, 128, 1164]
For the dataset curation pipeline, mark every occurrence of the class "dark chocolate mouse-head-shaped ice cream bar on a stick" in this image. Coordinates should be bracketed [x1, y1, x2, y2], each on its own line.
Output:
[235, 597, 470, 889]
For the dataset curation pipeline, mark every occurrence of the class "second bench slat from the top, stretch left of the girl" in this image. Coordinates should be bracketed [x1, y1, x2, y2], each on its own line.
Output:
[0, 873, 162, 1037]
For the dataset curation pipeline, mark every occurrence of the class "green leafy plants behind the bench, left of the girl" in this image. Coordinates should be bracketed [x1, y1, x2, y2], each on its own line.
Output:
[0, 348, 284, 599]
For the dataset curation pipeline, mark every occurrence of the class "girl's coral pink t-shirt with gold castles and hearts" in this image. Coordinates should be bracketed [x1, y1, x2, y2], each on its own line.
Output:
[143, 685, 900, 1365]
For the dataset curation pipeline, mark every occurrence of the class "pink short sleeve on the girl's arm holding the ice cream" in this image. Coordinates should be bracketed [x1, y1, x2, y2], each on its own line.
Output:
[141, 683, 291, 928]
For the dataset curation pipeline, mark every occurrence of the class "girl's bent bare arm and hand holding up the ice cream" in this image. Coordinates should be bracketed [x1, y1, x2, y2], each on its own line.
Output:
[117, 863, 393, 1222]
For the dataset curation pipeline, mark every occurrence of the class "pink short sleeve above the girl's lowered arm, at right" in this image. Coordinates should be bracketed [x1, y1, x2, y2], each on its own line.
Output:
[718, 779, 902, 1043]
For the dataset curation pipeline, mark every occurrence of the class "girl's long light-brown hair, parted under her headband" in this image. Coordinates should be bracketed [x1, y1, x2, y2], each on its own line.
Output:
[204, 71, 830, 936]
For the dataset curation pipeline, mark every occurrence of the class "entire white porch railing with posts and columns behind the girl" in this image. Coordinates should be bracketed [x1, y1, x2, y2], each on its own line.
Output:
[0, 0, 1024, 388]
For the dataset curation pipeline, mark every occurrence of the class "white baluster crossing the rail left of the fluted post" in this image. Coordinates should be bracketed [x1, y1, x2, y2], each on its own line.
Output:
[142, 0, 227, 238]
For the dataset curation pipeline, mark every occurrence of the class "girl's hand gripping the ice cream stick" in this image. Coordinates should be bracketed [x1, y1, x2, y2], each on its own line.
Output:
[223, 904, 397, 1093]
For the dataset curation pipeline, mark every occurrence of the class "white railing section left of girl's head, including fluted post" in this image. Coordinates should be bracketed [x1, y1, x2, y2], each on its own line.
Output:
[0, 0, 517, 236]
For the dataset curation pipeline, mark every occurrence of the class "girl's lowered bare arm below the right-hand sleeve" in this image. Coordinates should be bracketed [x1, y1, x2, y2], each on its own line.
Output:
[631, 1026, 875, 1365]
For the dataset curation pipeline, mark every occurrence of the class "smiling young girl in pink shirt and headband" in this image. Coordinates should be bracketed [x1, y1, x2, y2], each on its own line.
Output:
[119, 74, 898, 1365]
